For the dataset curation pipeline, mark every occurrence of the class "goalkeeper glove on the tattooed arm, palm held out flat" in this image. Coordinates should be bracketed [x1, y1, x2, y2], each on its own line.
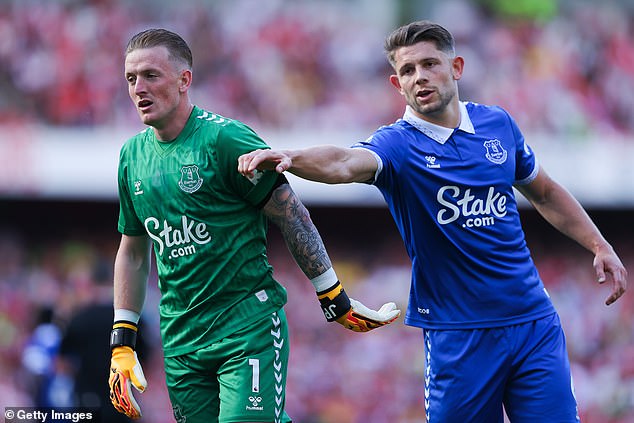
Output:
[317, 281, 401, 332]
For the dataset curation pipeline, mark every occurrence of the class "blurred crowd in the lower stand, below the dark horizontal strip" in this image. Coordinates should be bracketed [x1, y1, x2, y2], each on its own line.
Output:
[0, 211, 634, 423]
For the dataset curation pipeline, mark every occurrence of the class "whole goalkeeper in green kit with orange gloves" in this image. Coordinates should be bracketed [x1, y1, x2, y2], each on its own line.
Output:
[109, 29, 400, 423]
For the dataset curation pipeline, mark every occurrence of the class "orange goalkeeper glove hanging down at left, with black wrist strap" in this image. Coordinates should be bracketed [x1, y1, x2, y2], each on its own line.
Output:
[108, 321, 147, 419]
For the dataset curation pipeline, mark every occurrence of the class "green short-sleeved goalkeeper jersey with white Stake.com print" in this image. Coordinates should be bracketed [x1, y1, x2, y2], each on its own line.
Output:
[118, 107, 286, 356]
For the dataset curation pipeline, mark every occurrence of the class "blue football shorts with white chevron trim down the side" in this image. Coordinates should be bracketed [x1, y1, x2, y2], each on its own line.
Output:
[424, 313, 579, 423]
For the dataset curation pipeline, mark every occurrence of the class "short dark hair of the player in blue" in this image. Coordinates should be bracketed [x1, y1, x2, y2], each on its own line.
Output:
[384, 20, 455, 66]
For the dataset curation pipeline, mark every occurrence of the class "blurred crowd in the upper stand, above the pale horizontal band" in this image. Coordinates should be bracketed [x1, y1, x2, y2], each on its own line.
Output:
[0, 0, 634, 140]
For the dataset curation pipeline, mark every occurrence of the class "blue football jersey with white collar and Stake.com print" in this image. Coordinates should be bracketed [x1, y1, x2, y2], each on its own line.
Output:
[352, 102, 555, 329]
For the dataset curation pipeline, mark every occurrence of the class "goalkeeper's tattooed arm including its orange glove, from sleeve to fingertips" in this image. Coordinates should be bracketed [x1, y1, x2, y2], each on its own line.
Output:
[263, 183, 401, 332]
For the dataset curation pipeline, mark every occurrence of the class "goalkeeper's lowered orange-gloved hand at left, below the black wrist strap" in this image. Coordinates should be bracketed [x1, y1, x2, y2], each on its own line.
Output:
[108, 347, 147, 419]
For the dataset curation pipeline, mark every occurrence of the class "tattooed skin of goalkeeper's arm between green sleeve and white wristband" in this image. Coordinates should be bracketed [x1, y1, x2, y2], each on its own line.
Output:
[262, 184, 332, 279]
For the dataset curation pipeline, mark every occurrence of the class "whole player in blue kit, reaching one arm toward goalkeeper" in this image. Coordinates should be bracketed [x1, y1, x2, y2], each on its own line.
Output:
[238, 21, 627, 423]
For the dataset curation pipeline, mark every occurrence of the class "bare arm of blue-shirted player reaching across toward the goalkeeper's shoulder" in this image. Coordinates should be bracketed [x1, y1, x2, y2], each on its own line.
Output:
[238, 145, 378, 184]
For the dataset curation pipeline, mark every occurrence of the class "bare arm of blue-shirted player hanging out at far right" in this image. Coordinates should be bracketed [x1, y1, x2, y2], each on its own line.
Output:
[517, 169, 627, 305]
